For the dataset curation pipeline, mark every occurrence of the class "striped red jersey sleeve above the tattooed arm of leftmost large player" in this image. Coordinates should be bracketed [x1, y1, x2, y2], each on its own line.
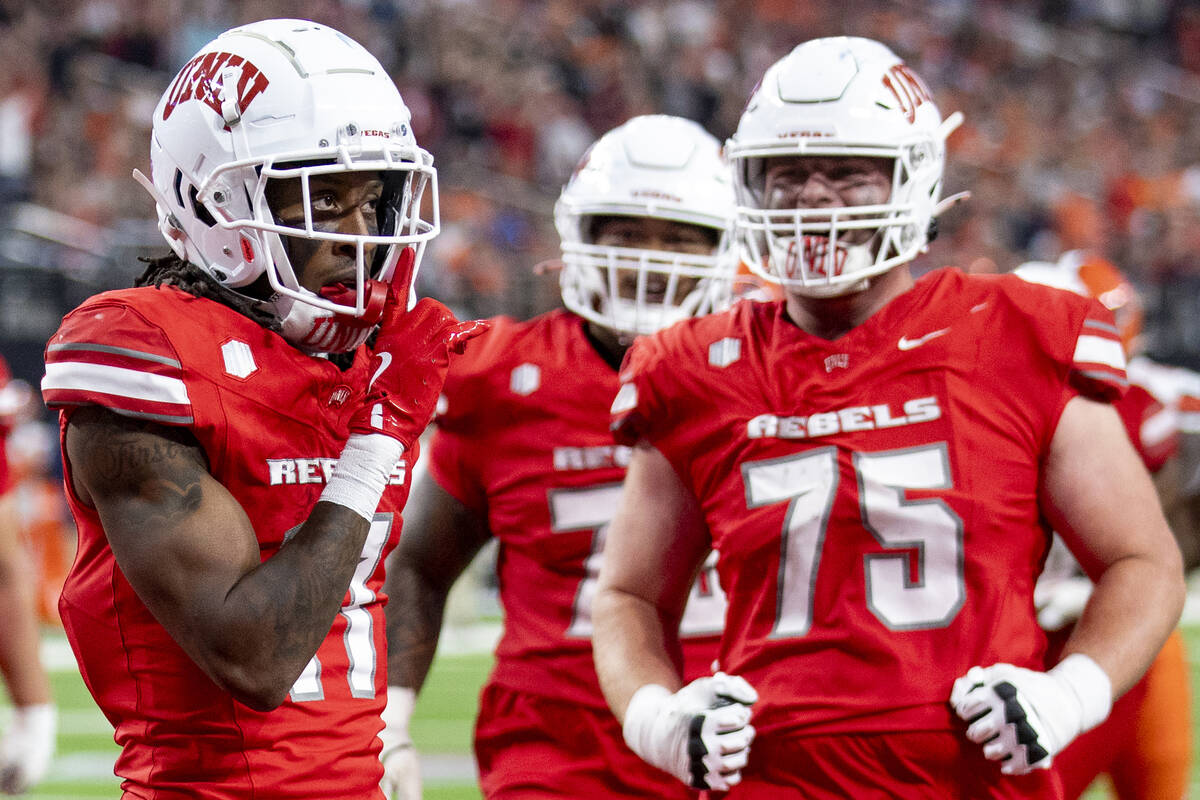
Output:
[42, 301, 194, 426]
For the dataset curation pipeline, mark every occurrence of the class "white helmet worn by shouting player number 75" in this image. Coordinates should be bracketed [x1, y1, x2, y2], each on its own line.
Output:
[725, 36, 962, 296]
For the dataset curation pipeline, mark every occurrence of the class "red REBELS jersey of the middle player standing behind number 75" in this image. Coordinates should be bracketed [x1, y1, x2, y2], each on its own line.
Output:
[428, 311, 725, 708]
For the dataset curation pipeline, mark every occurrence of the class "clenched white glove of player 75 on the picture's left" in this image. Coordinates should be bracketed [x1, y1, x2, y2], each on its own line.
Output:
[623, 672, 758, 790]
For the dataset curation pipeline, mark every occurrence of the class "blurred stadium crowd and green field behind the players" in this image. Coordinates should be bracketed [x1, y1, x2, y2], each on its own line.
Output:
[0, 0, 1200, 798]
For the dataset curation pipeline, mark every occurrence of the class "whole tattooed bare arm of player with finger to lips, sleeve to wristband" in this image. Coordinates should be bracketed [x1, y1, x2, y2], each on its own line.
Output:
[66, 407, 367, 709]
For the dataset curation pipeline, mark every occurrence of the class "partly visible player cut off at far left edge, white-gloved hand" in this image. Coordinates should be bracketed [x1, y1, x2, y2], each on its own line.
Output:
[0, 359, 58, 794]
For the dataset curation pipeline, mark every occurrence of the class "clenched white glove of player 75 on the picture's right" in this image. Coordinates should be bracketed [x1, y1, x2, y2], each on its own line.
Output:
[950, 652, 1112, 775]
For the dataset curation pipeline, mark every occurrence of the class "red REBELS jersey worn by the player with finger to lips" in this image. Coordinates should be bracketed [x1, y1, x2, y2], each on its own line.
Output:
[42, 288, 415, 800]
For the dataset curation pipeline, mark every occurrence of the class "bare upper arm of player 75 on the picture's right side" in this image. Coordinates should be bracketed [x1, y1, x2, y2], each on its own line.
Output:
[1042, 397, 1175, 578]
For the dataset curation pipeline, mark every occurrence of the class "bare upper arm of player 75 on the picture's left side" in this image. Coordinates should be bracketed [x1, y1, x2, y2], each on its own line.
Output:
[600, 441, 712, 614]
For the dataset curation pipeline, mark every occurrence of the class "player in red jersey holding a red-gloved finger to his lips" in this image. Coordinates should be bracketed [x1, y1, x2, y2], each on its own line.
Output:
[42, 19, 475, 800]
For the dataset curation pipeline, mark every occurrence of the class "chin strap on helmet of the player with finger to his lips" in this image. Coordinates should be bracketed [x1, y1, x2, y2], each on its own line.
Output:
[275, 281, 388, 353]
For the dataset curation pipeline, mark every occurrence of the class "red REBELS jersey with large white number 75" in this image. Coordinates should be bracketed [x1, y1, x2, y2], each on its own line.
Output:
[614, 269, 1127, 735]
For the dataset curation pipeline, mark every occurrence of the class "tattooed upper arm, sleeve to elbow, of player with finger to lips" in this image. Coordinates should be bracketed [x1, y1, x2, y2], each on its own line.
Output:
[66, 407, 259, 638]
